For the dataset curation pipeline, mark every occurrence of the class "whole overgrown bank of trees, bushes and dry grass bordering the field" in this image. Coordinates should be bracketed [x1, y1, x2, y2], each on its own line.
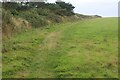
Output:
[2, 2, 99, 39]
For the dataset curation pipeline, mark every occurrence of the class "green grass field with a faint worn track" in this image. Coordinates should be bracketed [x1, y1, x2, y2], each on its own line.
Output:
[3, 18, 118, 78]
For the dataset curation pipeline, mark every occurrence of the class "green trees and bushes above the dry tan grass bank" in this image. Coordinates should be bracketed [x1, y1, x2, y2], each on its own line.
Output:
[3, 2, 75, 27]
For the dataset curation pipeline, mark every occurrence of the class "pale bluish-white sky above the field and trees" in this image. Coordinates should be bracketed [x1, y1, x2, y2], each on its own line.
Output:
[47, 0, 120, 17]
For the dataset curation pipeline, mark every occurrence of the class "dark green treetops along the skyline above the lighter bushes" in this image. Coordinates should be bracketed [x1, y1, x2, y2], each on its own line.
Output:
[3, 0, 75, 16]
